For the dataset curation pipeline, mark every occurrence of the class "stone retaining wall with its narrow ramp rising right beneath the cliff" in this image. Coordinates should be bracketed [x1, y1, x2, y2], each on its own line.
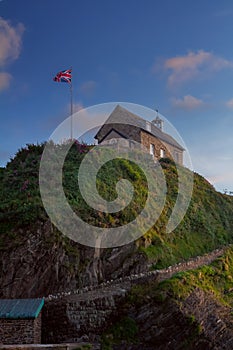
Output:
[42, 248, 224, 343]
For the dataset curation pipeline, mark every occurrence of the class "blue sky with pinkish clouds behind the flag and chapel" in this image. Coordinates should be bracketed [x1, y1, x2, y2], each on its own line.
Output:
[0, 0, 233, 192]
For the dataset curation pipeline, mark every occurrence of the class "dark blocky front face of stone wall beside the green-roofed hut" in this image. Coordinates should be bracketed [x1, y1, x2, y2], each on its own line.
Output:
[42, 290, 126, 344]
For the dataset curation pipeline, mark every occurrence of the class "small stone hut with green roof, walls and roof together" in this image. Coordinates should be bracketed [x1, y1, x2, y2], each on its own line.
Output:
[0, 299, 44, 345]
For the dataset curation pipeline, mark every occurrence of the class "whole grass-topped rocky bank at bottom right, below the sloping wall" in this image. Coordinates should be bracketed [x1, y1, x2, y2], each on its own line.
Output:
[102, 247, 233, 350]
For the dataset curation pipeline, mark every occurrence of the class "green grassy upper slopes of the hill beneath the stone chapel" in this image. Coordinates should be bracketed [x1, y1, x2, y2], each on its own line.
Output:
[0, 142, 233, 268]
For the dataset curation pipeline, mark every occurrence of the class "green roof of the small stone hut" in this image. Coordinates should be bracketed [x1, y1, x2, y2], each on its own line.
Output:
[0, 299, 44, 319]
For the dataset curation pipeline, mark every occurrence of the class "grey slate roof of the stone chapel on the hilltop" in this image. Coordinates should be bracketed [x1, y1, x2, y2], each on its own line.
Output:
[95, 105, 184, 151]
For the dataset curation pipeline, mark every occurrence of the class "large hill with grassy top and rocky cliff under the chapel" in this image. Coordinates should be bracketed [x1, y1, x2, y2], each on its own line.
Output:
[0, 142, 233, 297]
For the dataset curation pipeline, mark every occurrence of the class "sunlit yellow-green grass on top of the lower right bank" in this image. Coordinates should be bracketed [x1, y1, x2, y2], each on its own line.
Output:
[128, 246, 233, 306]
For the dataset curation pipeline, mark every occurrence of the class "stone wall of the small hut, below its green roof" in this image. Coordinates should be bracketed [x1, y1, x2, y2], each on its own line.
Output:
[0, 314, 41, 344]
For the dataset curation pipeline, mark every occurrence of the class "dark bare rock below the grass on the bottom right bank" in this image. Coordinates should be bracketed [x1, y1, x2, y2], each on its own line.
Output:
[104, 289, 233, 350]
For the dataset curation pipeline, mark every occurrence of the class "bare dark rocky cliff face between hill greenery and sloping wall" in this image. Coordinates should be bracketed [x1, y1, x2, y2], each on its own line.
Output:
[0, 221, 147, 298]
